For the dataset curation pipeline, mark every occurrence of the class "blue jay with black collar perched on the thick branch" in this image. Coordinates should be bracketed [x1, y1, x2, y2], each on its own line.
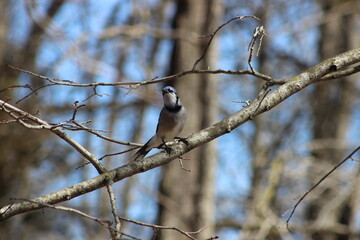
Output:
[129, 86, 186, 162]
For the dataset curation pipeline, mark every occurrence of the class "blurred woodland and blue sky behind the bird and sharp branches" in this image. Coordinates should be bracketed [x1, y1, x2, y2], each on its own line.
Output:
[0, 0, 360, 240]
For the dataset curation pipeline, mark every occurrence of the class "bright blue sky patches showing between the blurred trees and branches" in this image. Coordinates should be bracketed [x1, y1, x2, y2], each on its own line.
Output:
[9, 0, 360, 239]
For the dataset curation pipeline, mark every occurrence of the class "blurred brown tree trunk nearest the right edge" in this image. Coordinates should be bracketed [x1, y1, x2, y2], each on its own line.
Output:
[306, 0, 359, 240]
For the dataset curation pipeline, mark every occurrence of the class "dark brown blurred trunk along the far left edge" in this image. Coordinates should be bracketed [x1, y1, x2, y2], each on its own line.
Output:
[0, 0, 64, 239]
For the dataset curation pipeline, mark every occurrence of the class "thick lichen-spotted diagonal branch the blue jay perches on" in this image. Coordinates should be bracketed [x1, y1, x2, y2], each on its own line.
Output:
[0, 48, 360, 221]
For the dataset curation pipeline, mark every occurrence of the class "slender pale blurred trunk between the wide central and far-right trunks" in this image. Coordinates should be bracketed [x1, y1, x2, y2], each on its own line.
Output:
[239, 0, 286, 239]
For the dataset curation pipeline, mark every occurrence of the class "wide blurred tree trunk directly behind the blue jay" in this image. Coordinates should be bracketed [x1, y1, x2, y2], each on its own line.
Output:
[158, 0, 222, 239]
